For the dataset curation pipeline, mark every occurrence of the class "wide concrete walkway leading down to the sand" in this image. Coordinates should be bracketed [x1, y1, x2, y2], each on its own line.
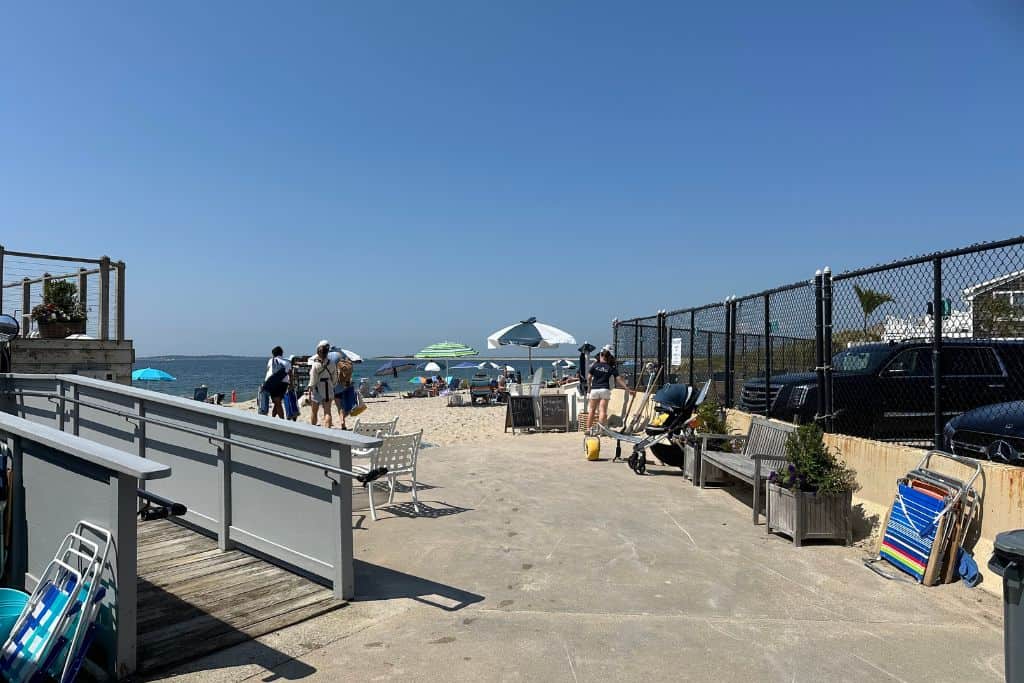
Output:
[149, 434, 1002, 682]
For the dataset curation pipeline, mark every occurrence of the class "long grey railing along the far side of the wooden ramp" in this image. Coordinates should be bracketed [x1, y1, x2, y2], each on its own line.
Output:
[0, 375, 372, 598]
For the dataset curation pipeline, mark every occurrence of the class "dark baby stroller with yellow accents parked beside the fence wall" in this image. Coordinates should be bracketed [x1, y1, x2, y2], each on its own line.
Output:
[602, 380, 711, 474]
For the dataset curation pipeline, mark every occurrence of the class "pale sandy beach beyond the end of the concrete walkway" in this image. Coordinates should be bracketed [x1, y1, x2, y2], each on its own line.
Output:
[235, 394, 512, 445]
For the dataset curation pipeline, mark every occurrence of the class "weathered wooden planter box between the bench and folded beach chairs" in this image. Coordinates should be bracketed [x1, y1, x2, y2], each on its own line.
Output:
[765, 483, 853, 547]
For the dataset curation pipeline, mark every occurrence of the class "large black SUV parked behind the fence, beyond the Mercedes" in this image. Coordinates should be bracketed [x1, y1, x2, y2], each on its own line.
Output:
[739, 339, 1024, 440]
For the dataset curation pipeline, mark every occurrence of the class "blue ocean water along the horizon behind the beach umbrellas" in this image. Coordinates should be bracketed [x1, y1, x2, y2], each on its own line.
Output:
[132, 356, 575, 401]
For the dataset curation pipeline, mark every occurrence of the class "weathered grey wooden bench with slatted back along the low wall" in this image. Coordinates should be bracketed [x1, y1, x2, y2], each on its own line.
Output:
[697, 416, 797, 524]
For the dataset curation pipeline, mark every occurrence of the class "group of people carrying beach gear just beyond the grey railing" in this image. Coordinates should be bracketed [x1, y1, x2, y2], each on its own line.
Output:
[258, 339, 361, 429]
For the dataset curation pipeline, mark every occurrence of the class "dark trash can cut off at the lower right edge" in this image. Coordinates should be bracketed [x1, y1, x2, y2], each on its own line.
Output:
[988, 529, 1024, 683]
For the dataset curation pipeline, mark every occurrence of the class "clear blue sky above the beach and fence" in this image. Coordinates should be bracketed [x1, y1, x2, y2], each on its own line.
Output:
[0, 0, 1024, 354]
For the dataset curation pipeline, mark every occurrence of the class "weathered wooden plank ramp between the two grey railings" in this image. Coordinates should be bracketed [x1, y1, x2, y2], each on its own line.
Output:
[138, 520, 344, 673]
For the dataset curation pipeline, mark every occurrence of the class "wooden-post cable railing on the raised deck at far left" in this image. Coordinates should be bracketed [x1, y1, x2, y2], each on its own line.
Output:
[0, 247, 125, 341]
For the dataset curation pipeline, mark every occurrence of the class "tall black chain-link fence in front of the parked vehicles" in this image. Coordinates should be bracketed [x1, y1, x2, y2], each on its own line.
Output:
[613, 237, 1024, 464]
